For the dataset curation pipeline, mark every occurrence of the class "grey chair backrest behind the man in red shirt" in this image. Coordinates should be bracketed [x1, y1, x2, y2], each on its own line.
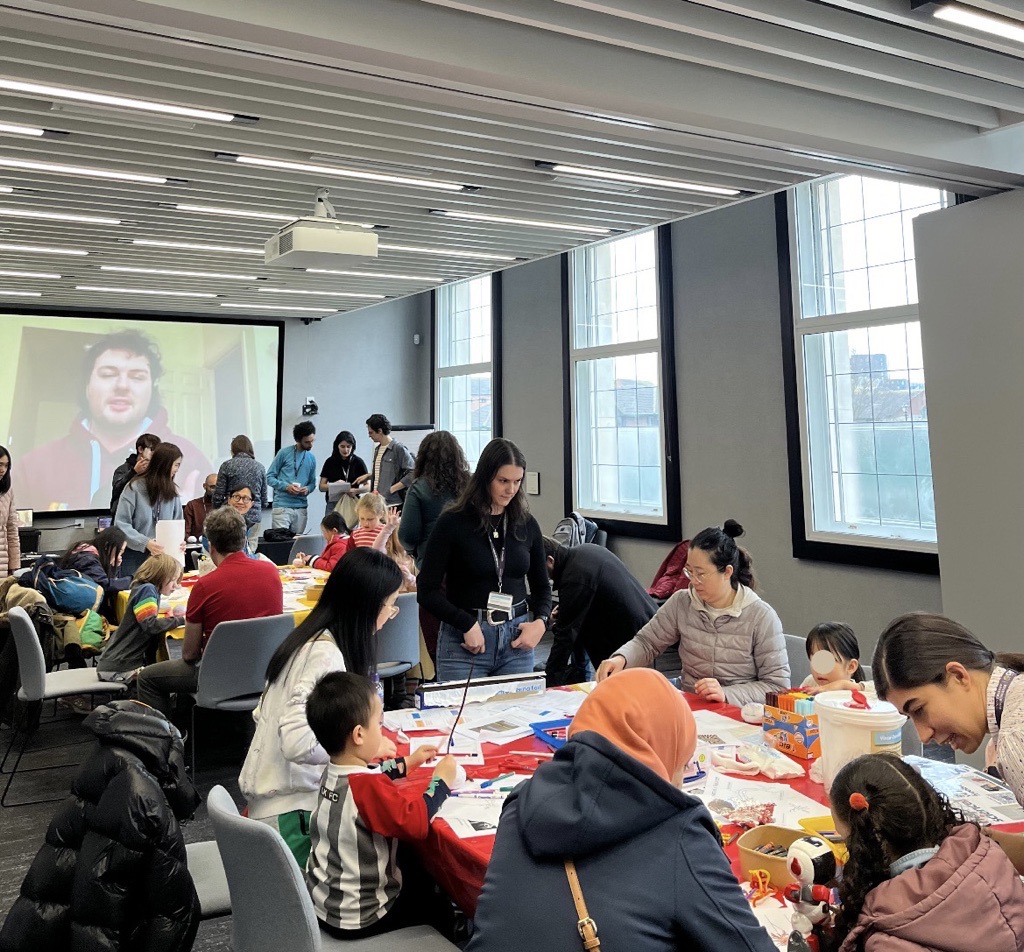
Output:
[196, 614, 295, 707]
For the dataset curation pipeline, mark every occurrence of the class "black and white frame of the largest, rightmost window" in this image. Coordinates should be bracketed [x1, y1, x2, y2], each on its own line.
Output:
[775, 189, 939, 575]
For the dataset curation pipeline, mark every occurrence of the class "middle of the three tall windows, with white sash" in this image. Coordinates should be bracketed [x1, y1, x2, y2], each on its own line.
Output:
[569, 230, 678, 526]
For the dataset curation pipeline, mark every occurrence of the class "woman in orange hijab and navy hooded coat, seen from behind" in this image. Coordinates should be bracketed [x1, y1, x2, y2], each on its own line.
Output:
[466, 668, 775, 952]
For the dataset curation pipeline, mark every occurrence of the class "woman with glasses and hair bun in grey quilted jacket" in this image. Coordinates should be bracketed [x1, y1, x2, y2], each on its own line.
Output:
[597, 519, 790, 705]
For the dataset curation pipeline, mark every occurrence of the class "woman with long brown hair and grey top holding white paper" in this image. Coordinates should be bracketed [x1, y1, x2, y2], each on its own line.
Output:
[114, 443, 184, 575]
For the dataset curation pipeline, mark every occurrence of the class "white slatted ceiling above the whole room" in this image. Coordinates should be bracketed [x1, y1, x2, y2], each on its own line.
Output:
[0, 0, 1024, 318]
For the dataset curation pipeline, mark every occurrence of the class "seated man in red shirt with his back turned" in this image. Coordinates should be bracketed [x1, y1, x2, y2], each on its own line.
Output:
[138, 506, 284, 713]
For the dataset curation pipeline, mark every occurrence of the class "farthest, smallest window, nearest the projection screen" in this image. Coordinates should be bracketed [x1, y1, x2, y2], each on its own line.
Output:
[435, 274, 494, 469]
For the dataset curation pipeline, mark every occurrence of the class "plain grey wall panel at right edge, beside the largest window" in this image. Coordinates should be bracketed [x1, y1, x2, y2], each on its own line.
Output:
[914, 191, 1024, 651]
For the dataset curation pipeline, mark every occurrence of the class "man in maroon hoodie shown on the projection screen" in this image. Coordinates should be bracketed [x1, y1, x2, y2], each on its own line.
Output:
[18, 331, 211, 510]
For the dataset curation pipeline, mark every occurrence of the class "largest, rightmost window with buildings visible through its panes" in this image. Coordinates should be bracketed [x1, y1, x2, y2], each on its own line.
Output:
[793, 176, 950, 552]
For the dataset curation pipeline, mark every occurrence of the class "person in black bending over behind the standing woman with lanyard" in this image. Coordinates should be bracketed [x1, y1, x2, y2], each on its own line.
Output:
[544, 536, 657, 686]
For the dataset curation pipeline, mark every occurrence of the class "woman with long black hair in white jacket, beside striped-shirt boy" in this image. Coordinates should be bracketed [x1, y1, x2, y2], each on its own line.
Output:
[239, 549, 401, 868]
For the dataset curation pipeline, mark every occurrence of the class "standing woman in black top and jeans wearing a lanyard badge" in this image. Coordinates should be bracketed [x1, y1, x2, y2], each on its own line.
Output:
[418, 439, 551, 681]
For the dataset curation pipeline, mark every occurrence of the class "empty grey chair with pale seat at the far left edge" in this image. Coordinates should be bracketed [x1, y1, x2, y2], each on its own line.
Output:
[0, 608, 126, 807]
